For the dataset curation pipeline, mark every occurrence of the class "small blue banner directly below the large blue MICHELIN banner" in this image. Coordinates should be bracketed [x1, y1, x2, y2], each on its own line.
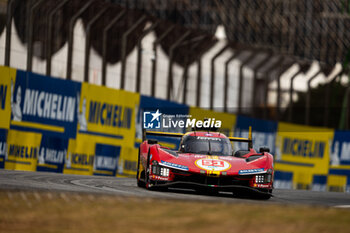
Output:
[37, 135, 68, 173]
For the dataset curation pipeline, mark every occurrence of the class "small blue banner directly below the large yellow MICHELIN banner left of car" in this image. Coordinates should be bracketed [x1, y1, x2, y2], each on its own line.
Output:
[94, 143, 121, 176]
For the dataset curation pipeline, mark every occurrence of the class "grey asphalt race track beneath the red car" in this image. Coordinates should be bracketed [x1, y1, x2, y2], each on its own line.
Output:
[0, 170, 350, 207]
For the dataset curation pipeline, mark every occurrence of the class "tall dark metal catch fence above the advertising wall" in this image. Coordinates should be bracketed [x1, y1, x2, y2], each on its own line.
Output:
[0, 0, 350, 128]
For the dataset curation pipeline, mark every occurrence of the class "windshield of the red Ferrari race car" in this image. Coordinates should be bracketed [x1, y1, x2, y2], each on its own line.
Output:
[180, 136, 232, 156]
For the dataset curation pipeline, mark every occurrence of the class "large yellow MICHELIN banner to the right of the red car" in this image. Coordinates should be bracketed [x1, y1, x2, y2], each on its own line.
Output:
[275, 123, 334, 189]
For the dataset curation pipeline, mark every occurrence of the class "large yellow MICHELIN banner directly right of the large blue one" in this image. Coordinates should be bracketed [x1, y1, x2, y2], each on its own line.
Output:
[78, 83, 140, 146]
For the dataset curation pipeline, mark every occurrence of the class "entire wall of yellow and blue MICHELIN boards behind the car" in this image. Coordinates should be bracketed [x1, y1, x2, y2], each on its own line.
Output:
[0, 66, 350, 192]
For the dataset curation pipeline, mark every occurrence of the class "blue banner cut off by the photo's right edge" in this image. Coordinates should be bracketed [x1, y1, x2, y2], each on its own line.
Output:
[330, 131, 350, 166]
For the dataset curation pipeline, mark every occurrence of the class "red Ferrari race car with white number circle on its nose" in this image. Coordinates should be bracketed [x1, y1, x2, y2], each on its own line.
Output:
[137, 129, 274, 199]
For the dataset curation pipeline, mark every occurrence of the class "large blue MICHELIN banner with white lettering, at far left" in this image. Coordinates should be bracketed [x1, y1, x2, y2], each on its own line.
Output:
[10, 70, 81, 138]
